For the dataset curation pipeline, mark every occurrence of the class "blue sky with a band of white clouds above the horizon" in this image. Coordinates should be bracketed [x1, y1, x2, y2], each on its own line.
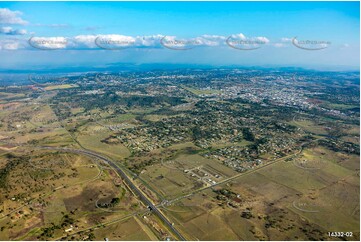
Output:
[0, 2, 360, 69]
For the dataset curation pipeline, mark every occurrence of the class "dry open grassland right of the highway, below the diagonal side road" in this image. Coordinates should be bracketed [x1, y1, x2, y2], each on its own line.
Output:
[163, 147, 360, 240]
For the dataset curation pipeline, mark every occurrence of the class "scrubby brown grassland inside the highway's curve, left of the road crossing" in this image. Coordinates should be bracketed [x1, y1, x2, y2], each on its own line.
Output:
[0, 150, 148, 240]
